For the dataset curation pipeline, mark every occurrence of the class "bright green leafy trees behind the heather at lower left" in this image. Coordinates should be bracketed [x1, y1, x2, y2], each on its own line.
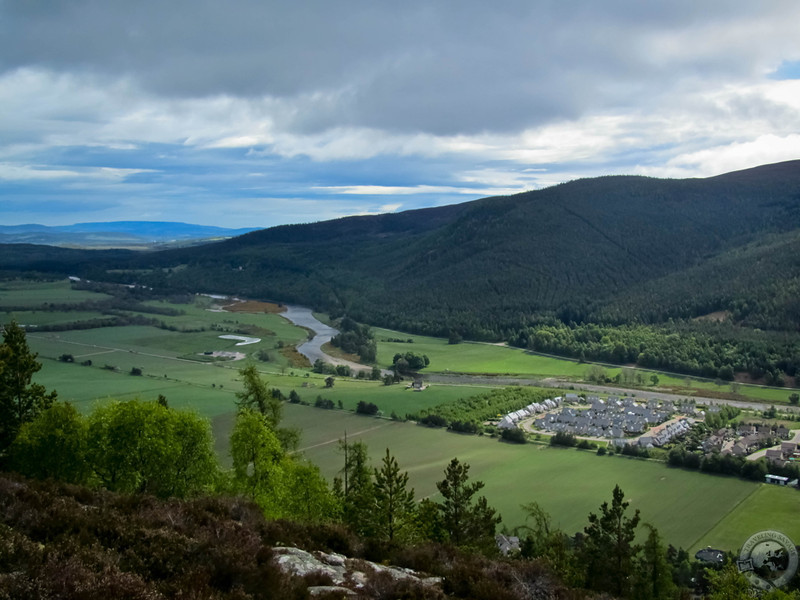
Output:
[7, 367, 339, 522]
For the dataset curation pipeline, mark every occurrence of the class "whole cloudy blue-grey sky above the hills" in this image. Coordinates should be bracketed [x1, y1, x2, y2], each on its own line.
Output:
[0, 0, 800, 227]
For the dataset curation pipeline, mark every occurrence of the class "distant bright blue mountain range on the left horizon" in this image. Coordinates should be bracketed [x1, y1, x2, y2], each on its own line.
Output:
[0, 221, 255, 248]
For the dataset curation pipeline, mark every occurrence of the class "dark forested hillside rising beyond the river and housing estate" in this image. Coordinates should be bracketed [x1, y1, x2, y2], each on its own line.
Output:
[0, 161, 800, 375]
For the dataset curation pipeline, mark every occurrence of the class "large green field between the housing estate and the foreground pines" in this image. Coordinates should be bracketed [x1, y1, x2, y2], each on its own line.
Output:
[270, 406, 776, 550]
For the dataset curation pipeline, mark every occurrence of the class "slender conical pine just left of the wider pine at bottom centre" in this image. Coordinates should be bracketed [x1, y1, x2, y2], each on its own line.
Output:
[374, 448, 416, 542]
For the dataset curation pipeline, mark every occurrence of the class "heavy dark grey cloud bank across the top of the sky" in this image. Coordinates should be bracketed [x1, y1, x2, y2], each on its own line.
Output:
[0, 0, 783, 134]
